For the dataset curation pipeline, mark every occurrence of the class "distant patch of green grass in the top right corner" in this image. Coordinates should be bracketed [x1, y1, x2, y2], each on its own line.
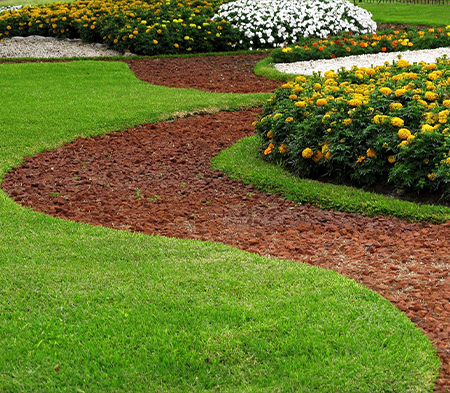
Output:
[356, 2, 450, 26]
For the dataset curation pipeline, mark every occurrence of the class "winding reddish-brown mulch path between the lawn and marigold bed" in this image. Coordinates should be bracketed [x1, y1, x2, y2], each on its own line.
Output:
[2, 55, 450, 392]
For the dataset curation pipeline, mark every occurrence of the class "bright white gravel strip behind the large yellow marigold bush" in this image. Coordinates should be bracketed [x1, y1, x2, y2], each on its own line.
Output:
[274, 47, 450, 75]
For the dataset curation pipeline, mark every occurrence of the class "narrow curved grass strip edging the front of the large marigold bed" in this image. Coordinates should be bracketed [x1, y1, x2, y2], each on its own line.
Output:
[213, 137, 450, 223]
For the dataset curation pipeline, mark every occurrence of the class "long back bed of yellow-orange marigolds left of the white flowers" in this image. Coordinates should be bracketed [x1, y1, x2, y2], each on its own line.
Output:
[0, 0, 241, 55]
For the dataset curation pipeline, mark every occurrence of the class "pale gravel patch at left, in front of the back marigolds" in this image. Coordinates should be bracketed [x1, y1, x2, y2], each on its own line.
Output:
[0, 36, 130, 58]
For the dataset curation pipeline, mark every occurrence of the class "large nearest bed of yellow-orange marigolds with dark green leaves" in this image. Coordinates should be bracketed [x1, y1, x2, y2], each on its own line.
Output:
[254, 60, 450, 198]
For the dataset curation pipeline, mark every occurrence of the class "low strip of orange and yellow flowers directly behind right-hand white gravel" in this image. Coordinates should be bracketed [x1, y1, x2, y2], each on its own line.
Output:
[271, 25, 450, 63]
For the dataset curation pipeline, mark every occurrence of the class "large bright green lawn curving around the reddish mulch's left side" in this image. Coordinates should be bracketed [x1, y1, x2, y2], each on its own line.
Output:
[0, 62, 439, 392]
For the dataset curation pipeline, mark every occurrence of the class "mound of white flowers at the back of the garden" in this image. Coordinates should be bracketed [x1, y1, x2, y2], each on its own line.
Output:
[213, 0, 377, 49]
